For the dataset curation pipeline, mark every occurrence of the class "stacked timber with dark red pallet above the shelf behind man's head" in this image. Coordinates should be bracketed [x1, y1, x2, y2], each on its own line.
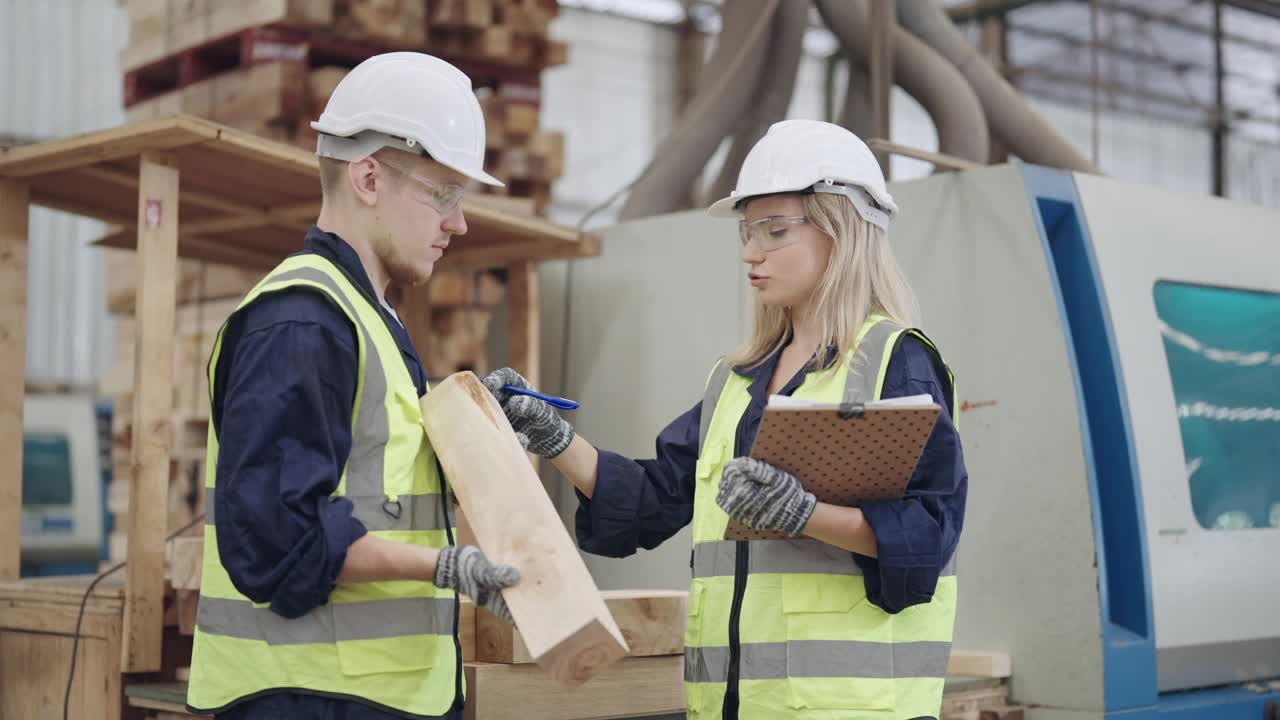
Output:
[120, 0, 567, 211]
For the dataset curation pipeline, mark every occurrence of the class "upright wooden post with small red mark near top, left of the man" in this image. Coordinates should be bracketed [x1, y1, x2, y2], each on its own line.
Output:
[122, 151, 179, 673]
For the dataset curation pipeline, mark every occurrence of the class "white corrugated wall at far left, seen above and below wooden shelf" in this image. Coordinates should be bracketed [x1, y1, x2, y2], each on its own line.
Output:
[0, 0, 128, 386]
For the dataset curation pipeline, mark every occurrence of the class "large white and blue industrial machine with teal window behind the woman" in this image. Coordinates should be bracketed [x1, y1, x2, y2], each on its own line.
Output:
[555, 164, 1280, 720]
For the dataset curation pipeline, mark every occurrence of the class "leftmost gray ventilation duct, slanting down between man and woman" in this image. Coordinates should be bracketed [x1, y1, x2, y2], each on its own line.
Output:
[618, 0, 791, 220]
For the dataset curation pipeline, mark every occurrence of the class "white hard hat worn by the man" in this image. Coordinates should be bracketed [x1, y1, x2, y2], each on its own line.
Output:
[311, 53, 502, 186]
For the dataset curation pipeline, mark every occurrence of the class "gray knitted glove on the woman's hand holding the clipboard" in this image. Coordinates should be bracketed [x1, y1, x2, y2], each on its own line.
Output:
[716, 457, 818, 537]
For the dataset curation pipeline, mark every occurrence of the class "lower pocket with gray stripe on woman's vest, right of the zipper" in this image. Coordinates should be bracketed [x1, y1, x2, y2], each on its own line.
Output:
[782, 574, 896, 711]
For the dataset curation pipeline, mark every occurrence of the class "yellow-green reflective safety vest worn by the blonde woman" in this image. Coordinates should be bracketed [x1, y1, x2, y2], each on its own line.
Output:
[685, 316, 956, 720]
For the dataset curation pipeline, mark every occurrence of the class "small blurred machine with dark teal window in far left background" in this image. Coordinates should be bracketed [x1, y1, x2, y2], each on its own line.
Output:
[22, 393, 110, 575]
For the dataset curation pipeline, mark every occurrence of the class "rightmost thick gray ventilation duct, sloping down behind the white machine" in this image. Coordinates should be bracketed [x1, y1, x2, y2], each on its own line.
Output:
[896, 0, 1098, 173]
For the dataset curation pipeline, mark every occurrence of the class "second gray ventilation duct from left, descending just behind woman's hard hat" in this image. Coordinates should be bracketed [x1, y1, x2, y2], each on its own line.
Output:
[708, 0, 809, 201]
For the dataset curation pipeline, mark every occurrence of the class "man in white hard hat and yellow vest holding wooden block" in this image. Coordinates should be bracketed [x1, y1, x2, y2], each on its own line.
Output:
[187, 53, 518, 720]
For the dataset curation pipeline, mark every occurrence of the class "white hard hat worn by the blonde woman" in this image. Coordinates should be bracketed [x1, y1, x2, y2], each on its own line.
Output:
[708, 120, 897, 229]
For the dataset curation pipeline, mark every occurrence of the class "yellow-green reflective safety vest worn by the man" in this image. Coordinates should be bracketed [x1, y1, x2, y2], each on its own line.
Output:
[187, 254, 463, 716]
